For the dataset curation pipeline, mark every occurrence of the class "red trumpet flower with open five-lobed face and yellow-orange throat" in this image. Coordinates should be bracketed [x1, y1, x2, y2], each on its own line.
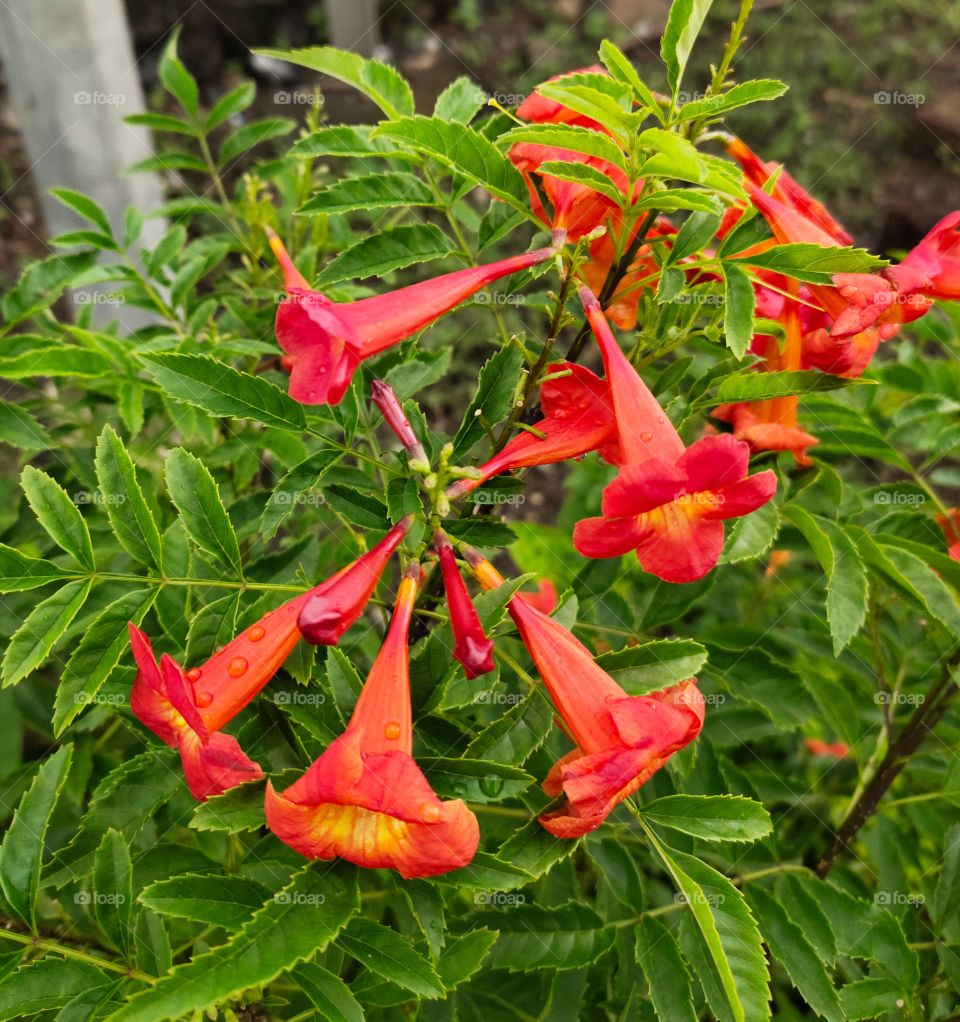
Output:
[574, 288, 777, 583]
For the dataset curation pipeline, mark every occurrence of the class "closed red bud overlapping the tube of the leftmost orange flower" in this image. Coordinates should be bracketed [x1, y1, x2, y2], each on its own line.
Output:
[298, 515, 413, 646]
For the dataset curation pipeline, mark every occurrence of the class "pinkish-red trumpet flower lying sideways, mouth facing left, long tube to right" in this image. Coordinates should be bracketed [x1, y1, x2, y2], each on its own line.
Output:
[269, 231, 562, 405]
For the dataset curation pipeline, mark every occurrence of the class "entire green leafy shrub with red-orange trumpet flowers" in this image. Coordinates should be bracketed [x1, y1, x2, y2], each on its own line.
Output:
[0, 7, 960, 1022]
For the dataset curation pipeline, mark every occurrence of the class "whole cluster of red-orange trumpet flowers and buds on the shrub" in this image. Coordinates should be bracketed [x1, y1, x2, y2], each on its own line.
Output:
[130, 61, 960, 878]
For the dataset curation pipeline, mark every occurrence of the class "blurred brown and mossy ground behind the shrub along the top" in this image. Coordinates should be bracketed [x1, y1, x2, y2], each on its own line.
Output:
[0, 0, 960, 285]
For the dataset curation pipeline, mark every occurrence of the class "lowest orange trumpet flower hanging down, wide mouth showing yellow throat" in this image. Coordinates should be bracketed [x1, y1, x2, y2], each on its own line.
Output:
[266, 565, 479, 879]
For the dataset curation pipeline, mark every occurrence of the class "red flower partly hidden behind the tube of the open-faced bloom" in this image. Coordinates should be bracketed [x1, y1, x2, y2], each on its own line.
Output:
[447, 362, 621, 500]
